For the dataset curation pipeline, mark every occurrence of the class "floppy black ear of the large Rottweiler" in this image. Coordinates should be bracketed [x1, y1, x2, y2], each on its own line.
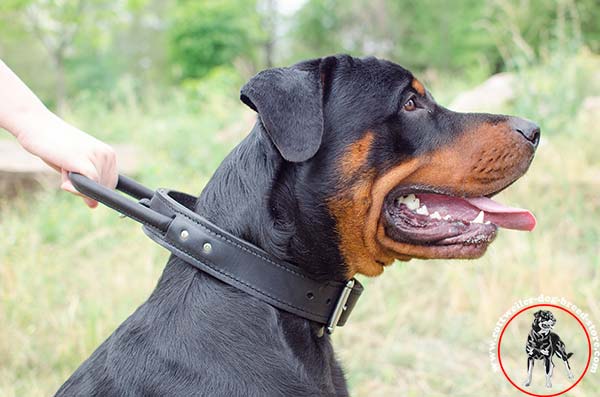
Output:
[240, 60, 323, 162]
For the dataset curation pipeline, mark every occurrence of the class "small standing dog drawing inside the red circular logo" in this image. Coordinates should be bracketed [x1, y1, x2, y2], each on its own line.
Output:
[524, 310, 573, 387]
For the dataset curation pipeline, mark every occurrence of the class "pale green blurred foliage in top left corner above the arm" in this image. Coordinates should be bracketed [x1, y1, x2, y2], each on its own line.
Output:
[0, 0, 167, 107]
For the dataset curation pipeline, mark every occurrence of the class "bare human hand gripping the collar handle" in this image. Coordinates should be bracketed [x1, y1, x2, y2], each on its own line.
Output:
[15, 111, 118, 208]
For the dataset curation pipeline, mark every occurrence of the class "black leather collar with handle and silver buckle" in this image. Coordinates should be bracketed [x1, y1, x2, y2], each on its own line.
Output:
[70, 173, 363, 333]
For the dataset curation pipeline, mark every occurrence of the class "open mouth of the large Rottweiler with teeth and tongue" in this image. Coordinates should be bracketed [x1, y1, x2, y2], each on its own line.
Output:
[382, 188, 536, 248]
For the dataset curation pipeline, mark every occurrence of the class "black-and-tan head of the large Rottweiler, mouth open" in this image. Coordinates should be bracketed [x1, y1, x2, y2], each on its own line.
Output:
[241, 56, 540, 277]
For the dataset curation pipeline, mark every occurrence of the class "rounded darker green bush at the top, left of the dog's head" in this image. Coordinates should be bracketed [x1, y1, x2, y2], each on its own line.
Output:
[169, 0, 260, 80]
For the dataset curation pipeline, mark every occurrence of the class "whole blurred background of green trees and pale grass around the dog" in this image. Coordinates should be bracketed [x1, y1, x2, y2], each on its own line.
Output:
[0, 0, 600, 397]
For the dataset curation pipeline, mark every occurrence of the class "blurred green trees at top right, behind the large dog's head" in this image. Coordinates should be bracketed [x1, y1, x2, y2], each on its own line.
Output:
[291, 0, 600, 80]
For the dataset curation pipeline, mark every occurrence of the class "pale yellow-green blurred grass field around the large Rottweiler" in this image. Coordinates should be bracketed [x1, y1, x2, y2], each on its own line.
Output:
[0, 53, 600, 397]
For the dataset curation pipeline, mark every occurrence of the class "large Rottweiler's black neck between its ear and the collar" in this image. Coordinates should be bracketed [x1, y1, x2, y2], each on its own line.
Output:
[196, 122, 345, 281]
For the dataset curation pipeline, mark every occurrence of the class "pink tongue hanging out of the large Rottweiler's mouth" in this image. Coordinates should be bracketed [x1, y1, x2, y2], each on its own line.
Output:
[464, 197, 536, 231]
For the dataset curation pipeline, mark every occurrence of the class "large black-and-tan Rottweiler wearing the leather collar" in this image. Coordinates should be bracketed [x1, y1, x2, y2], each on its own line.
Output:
[57, 56, 539, 397]
